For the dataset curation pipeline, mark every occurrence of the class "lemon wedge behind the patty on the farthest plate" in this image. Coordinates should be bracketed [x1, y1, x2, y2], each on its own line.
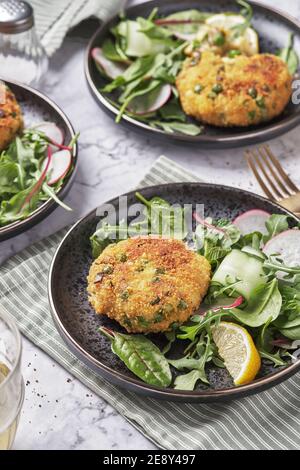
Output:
[206, 13, 259, 56]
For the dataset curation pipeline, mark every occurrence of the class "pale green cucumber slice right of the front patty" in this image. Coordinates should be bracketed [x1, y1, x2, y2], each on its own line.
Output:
[212, 250, 266, 300]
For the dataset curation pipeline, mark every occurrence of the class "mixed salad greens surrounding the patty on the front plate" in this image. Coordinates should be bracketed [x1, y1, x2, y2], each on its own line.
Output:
[91, 193, 300, 390]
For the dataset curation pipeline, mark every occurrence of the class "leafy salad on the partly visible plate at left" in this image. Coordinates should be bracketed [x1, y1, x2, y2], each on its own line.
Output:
[0, 123, 75, 227]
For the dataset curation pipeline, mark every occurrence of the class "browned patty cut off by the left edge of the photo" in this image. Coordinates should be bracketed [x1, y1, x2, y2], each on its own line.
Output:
[0, 84, 23, 151]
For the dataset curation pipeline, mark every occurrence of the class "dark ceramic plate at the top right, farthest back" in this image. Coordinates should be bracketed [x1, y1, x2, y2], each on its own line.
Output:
[85, 0, 300, 149]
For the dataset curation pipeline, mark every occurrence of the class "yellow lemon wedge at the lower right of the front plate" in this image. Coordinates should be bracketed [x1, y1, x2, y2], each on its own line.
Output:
[212, 322, 261, 385]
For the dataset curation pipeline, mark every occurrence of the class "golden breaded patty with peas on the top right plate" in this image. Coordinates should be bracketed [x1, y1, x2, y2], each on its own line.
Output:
[176, 51, 292, 127]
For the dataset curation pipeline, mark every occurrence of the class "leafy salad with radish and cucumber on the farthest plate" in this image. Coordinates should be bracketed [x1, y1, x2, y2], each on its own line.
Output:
[91, 0, 299, 136]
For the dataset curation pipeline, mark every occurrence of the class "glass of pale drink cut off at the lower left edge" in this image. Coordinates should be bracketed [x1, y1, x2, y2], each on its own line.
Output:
[0, 311, 24, 450]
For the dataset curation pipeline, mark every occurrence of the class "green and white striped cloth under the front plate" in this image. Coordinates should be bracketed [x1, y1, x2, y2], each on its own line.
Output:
[0, 157, 300, 450]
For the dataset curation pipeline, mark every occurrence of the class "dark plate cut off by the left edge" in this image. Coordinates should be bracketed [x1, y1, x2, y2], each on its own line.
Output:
[0, 81, 78, 241]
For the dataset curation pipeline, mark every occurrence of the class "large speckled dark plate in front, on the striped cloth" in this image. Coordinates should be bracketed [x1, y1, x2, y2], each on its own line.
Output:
[48, 183, 300, 402]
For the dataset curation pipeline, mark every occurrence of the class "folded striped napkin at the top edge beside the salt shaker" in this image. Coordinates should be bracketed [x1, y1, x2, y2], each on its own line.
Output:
[29, 0, 126, 56]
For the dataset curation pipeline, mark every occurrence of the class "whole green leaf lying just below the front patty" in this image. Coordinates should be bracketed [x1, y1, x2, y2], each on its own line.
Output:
[99, 328, 172, 388]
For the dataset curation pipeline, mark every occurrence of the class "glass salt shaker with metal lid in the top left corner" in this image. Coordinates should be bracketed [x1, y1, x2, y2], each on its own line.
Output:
[0, 0, 48, 86]
